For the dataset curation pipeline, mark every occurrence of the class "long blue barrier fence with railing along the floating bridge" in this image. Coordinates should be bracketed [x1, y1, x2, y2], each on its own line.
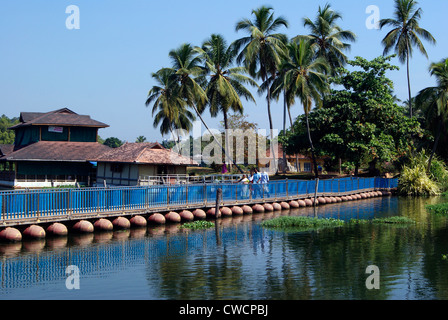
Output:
[0, 177, 398, 222]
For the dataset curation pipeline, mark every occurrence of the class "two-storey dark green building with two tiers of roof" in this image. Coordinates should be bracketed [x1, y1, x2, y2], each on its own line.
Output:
[0, 108, 110, 188]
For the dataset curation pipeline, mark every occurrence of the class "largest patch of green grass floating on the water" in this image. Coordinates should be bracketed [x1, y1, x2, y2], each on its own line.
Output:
[261, 216, 344, 229]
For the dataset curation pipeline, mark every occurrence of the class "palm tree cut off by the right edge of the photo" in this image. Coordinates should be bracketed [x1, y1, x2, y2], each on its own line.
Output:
[415, 58, 448, 171]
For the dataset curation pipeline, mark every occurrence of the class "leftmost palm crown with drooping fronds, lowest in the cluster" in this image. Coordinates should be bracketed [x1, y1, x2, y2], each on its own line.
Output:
[145, 68, 195, 142]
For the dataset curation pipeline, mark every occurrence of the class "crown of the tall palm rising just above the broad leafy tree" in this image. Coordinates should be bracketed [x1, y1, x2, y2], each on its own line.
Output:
[293, 4, 356, 74]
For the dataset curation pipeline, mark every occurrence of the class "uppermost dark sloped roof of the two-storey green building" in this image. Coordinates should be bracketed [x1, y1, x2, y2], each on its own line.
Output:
[9, 108, 109, 129]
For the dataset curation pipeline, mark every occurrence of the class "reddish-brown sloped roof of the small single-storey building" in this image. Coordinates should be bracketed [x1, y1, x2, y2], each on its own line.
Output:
[94, 142, 198, 165]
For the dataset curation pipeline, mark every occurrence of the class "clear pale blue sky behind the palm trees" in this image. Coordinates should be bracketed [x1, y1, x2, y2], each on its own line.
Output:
[0, 0, 448, 142]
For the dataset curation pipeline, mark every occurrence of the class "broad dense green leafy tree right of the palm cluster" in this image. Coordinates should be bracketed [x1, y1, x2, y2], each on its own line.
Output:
[280, 56, 422, 174]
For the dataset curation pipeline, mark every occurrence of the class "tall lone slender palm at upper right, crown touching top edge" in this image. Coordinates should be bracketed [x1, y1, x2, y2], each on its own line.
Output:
[379, 0, 436, 118]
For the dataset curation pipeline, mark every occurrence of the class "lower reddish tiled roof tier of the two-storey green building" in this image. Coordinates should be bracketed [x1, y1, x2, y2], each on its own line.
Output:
[0, 141, 110, 161]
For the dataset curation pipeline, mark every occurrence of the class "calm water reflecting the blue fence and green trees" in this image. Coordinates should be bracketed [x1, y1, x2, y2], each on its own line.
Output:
[0, 197, 448, 300]
